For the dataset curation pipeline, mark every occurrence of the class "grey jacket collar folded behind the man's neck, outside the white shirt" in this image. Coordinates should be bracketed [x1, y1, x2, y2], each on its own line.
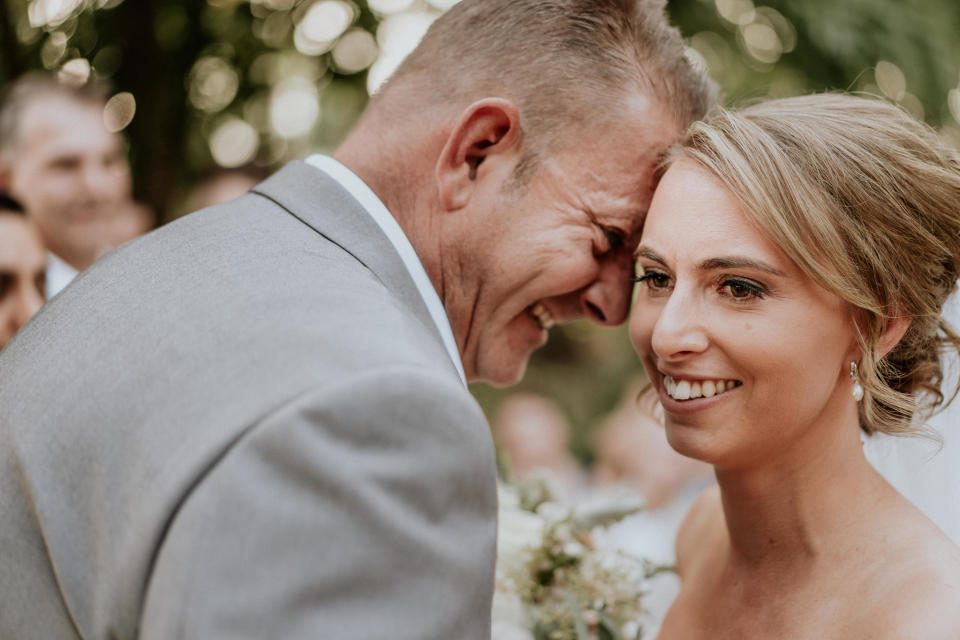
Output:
[253, 162, 442, 350]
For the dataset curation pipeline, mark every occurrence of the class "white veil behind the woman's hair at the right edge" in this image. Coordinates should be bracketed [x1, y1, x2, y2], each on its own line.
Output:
[864, 284, 960, 546]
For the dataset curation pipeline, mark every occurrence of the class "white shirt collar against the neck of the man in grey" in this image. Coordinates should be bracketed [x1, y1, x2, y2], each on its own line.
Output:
[306, 154, 467, 386]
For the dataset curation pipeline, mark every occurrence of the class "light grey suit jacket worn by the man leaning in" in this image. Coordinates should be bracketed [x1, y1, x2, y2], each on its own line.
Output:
[0, 163, 496, 640]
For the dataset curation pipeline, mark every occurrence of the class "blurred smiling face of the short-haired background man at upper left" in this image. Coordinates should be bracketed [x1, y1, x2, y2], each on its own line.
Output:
[6, 95, 130, 269]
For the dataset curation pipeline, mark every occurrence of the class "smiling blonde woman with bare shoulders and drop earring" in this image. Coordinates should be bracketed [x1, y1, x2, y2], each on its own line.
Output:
[631, 95, 960, 639]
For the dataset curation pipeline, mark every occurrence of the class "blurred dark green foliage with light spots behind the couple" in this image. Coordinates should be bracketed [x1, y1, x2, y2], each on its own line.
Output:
[0, 0, 960, 461]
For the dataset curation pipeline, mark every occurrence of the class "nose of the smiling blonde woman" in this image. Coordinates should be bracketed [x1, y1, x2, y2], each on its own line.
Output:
[651, 286, 709, 362]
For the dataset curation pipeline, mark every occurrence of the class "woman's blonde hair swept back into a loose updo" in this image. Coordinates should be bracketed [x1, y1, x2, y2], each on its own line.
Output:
[667, 94, 960, 435]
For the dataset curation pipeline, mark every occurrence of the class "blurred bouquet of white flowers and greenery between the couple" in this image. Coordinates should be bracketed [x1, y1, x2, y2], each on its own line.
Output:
[493, 481, 662, 640]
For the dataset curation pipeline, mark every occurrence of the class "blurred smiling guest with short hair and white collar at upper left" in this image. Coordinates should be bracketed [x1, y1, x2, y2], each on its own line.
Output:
[0, 73, 139, 298]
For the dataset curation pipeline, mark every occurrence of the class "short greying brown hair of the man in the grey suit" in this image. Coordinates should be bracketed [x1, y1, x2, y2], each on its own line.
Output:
[371, 0, 715, 179]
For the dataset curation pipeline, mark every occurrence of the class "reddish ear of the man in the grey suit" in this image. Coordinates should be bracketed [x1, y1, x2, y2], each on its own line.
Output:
[436, 98, 521, 211]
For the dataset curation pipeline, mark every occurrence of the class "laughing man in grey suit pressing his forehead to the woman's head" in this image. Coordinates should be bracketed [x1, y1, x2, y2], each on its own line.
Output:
[0, 0, 709, 640]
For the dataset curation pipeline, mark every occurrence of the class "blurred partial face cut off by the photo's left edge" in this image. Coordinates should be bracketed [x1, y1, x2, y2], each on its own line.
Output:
[0, 211, 46, 349]
